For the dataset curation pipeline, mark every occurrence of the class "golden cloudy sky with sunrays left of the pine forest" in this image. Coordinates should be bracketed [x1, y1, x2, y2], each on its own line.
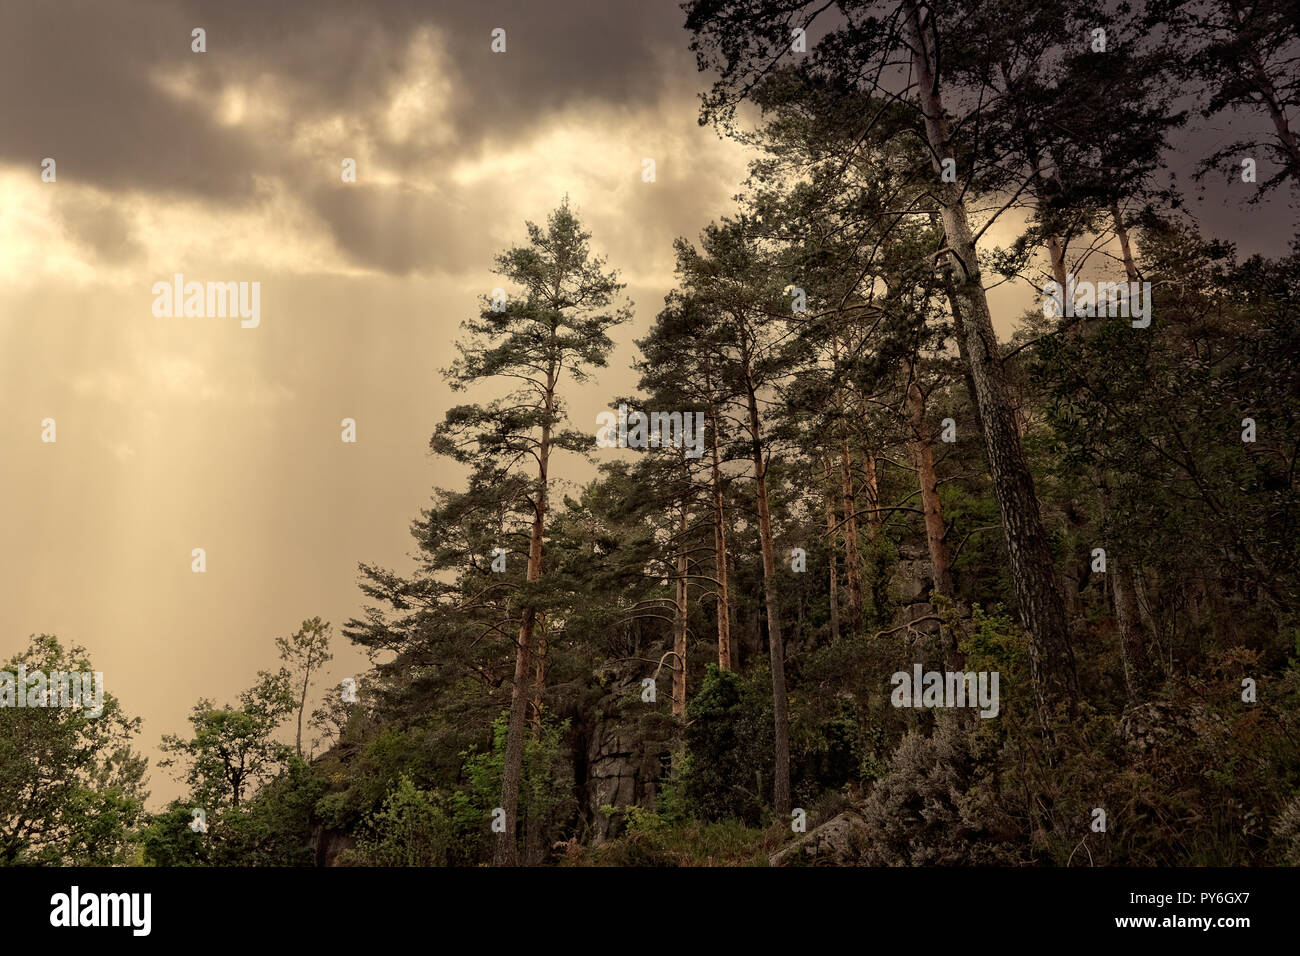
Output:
[0, 0, 1286, 808]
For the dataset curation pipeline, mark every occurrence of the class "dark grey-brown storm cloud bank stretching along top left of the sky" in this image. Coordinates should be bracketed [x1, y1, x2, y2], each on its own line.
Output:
[0, 0, 690, 188]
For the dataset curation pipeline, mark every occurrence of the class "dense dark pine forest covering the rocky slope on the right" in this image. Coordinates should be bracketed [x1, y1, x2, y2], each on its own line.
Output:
[2, 0, 1300, 865]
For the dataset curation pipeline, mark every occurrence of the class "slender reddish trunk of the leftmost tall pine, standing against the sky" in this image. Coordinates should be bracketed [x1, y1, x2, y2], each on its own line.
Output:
[493, 361, 556, 866]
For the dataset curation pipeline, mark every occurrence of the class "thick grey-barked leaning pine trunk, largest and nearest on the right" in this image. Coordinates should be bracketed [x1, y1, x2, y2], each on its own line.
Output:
[904, 0, 1078, 730]
